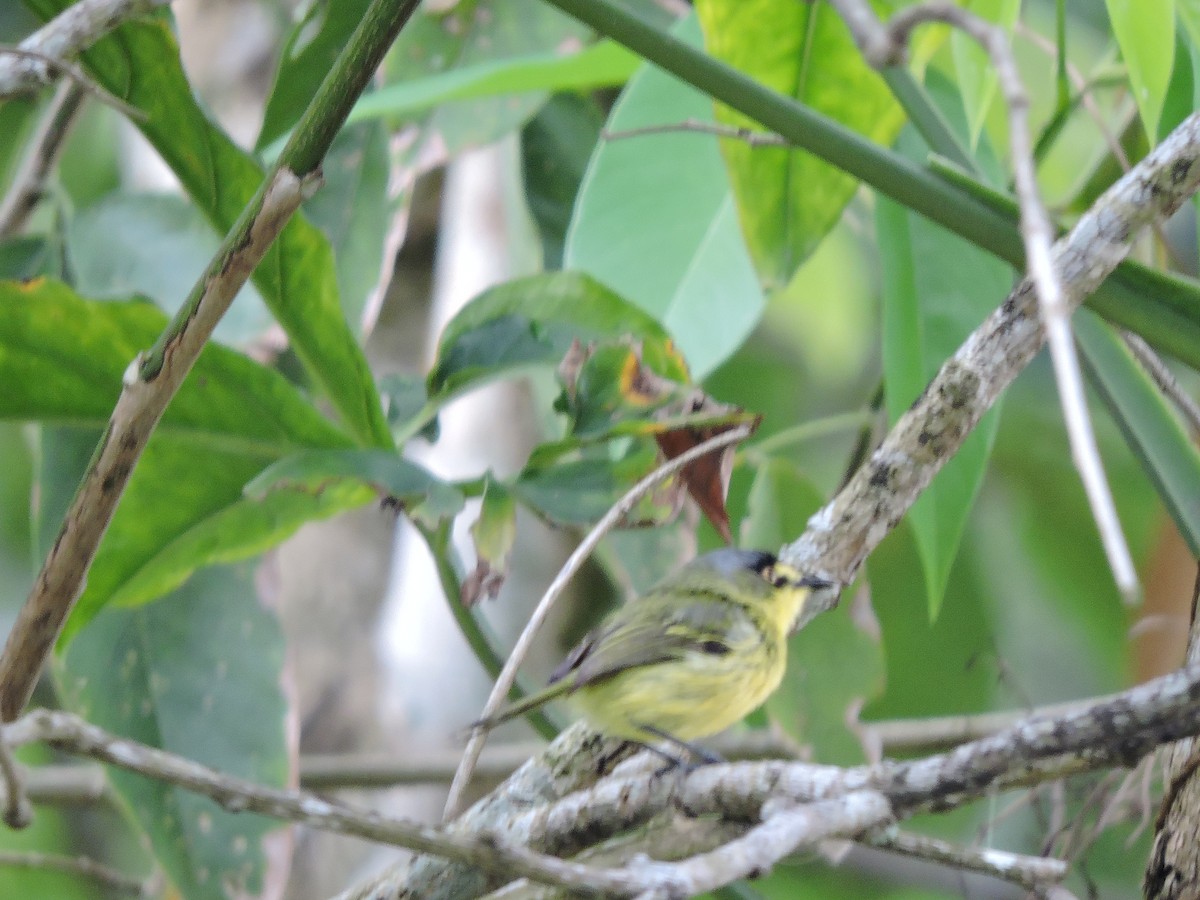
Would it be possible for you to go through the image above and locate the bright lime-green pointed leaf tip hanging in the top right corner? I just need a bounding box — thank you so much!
[1105,0,1175,143]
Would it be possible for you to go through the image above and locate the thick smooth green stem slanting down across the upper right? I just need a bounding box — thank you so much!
[545,0,1200,367]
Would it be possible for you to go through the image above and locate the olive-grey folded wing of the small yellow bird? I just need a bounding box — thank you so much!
[550,598,756,690]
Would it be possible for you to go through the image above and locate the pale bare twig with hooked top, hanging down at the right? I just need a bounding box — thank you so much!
[832,0,1139,602]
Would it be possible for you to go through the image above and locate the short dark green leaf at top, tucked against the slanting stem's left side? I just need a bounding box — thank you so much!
[256,0,371,151]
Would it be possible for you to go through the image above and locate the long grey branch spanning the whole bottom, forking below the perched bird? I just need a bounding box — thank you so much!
[7,664,1200,895]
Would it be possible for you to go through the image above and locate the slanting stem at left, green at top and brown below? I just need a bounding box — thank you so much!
[0,0,427,721]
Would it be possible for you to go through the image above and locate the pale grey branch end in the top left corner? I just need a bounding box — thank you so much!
[0,0,170,98]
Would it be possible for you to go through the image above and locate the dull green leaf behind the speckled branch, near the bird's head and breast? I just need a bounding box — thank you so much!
[740,460,883,764]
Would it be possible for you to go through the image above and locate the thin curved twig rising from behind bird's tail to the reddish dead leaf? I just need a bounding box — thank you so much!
[444,425,754,821]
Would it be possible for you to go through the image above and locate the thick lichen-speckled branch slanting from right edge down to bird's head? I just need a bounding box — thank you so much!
[782,105,1200,600]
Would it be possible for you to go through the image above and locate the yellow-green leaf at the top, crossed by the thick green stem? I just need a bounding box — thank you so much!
[696,0,904,289]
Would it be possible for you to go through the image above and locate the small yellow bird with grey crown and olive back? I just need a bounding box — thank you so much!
[475,548,832,760]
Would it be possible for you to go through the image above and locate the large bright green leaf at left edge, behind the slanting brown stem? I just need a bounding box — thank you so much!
[0,281,367,635]
